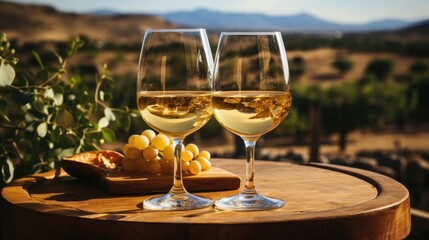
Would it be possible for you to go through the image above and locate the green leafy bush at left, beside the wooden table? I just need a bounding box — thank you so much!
[0,34,135,184]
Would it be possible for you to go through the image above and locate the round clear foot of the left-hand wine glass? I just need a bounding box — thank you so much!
[143,193,213,210]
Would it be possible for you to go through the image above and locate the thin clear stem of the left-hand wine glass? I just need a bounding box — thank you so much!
[170,139,187,195]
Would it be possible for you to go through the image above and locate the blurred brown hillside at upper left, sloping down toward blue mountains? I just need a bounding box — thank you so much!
[0,1,177,43]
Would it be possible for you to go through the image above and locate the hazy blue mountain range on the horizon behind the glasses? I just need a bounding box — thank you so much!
[158,9,412,33]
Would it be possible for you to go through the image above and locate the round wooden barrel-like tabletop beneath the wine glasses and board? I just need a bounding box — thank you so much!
[0,159,411,240]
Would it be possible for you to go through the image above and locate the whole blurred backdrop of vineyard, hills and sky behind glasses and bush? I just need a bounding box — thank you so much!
[0,0,429,239]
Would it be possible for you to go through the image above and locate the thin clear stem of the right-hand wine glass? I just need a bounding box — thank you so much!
[241,139,258,194]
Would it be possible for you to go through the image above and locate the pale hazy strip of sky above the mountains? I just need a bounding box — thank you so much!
[8,0,429,24]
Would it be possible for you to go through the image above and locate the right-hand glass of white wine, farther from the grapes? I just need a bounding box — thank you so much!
[213,32,292,211]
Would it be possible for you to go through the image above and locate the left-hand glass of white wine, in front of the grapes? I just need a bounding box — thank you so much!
[137,29,213,210]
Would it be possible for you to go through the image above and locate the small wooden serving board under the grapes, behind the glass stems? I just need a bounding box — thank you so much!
[101,167,241,194]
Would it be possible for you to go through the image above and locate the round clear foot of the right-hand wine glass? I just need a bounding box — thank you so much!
[215,193,285,211]
